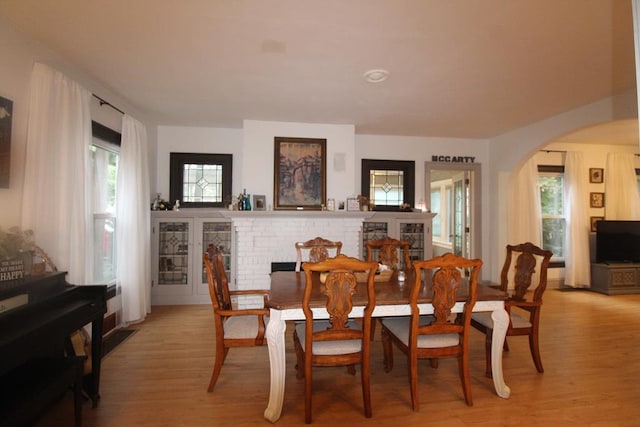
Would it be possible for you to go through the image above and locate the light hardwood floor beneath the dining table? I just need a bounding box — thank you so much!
[39,290,640,427]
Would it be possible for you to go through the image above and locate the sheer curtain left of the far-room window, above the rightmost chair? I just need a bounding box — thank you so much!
[507,157,542,247]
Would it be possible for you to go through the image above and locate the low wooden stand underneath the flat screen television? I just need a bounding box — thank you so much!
[591,262,640,295]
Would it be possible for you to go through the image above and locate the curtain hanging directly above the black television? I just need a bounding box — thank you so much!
[604,153,640,220]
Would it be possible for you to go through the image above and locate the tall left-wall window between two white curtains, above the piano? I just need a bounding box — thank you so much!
[90,122,121,284]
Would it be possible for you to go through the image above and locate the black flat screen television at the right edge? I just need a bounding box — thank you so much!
[596,220,640,263]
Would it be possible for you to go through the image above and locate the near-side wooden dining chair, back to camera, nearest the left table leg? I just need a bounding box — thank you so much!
[294,255,377,424]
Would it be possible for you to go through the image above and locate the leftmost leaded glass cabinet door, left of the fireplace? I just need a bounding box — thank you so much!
[157,222,190,287]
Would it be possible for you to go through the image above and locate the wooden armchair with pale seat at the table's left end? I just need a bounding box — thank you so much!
[202,245,269,392]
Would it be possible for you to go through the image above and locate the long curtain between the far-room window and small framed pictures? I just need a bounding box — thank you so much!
[564,151,591,288]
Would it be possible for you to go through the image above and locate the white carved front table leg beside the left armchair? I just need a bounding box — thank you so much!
[264,309,287,423]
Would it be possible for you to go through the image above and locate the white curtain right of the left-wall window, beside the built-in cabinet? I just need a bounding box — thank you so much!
[116,114,151,324]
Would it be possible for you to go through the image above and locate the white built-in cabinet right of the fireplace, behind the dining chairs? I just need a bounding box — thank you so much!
[362,212,433,268]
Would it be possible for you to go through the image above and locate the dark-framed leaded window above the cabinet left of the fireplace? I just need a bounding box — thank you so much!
[170,153,233,208]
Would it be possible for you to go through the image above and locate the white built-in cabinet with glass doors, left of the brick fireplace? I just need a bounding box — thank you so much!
[151,209,234,305]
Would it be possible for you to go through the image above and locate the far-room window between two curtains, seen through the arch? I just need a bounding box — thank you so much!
[538,165,566,261]
